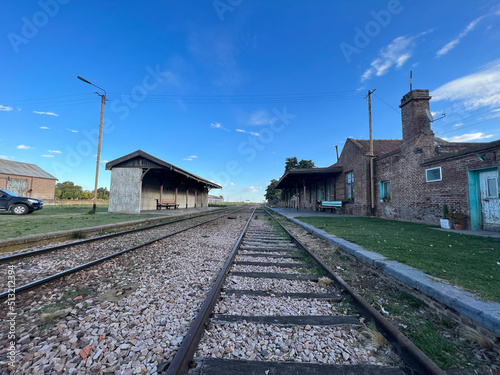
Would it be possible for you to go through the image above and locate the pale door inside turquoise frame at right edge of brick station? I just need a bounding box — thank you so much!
[479,171,500,230]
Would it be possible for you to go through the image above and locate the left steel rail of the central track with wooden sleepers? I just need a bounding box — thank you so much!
[165,208,256,375]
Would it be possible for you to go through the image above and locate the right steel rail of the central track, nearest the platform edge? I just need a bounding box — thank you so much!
[266,209,446,375]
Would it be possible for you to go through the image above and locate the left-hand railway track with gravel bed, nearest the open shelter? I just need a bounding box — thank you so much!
[0,209,242,302]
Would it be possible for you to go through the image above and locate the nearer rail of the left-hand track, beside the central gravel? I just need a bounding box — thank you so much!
[0,209,246,302]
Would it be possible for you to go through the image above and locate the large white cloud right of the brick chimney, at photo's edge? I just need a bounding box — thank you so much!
[431,59,500,110]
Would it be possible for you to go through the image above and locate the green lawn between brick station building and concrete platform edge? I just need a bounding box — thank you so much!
[297,217,500,302]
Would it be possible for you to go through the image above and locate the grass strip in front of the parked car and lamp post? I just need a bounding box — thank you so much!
[0,205,170,239]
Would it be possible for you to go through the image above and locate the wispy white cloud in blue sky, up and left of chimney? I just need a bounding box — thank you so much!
[361,34,414,82]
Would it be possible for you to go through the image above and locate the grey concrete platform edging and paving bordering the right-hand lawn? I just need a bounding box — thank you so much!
[272,208,500,335]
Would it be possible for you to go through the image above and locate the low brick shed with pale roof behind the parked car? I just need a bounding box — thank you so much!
[0,159,57,199]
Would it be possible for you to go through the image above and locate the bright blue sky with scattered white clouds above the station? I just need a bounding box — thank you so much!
[0,0,500,201]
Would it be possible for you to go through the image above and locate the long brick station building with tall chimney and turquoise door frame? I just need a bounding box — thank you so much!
[277,90,500,231]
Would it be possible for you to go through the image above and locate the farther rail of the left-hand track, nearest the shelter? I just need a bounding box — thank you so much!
[0,208,241,264]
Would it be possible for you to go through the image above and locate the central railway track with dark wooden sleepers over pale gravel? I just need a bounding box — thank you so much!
[164,210,444,375]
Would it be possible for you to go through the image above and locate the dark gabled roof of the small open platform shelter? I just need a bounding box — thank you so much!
[106,150,222,189]
